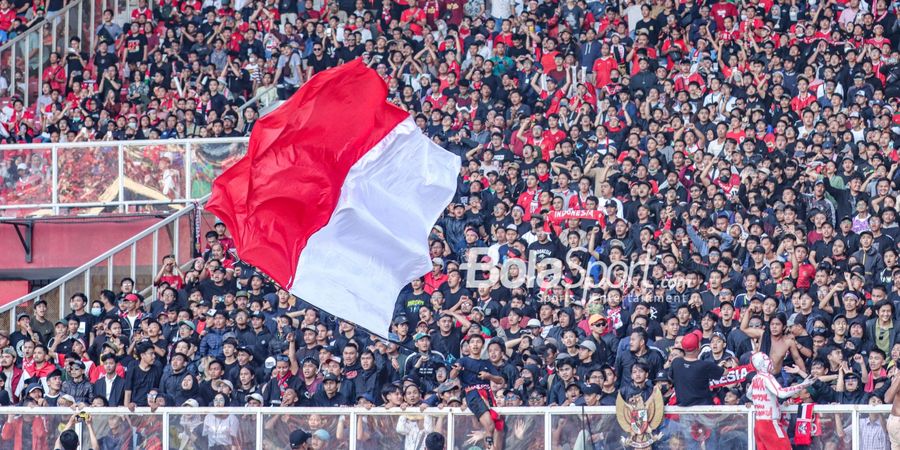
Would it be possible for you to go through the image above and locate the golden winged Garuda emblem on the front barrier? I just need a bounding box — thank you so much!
[616,388,663,449]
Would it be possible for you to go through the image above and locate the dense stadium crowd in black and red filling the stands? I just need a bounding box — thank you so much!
[0,0,900,448]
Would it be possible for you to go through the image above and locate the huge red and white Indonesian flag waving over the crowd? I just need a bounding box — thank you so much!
[207,60,460,335]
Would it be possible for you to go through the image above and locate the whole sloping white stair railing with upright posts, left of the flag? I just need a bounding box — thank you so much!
[0,195,208,332]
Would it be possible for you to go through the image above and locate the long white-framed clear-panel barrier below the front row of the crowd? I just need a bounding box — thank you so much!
[0,405,890,450]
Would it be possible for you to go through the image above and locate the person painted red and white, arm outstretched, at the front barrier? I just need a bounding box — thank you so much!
[747,352,816,450]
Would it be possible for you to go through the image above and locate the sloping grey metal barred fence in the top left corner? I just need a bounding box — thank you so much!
[0,0,131,108]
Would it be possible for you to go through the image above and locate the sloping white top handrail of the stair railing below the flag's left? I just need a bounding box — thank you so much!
[0,195,209,331]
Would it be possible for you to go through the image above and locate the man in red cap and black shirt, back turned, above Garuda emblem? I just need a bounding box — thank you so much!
[670,330,725,406]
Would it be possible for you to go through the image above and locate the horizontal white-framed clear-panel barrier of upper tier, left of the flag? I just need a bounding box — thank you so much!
[0,137,248,218]
